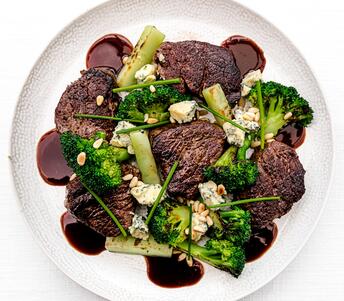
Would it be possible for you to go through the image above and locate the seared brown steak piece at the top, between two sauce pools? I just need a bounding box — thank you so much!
[155,41,241,103]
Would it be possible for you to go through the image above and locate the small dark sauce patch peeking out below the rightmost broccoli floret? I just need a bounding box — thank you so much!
[276,123,306,148]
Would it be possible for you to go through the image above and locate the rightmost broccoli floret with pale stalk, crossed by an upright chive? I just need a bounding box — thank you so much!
[247,81,313,135]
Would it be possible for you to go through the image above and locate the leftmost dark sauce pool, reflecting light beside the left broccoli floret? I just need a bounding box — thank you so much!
[37,129,73,186]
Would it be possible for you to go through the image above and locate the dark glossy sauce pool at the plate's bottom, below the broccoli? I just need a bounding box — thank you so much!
[146,255,204,288]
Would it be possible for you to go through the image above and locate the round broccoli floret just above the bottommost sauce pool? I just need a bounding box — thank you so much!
[149,200,190,246]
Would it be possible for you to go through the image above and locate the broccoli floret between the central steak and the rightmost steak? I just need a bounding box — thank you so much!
[203,146,258,193]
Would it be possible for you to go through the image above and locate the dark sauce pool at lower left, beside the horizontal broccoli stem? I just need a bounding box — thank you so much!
[61,212,105,255]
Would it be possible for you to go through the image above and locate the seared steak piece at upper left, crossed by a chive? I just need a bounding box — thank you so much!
[55,68,118,138]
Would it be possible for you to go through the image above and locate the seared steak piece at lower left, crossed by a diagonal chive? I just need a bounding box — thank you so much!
[65,164,140,236]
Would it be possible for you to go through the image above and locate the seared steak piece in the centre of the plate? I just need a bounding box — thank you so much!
[151,121,225,199]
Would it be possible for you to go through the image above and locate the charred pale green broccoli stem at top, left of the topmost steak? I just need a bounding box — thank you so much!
[117,25,165,87]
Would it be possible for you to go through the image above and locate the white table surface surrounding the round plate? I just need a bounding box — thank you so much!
[0,0,344,301]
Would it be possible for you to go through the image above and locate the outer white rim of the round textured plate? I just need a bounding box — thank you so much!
[8,0,336,300]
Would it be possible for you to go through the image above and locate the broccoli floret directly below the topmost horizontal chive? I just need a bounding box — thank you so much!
[116,85,191,121]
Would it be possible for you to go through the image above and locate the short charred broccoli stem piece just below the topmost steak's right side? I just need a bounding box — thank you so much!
[202,84,231,126]
